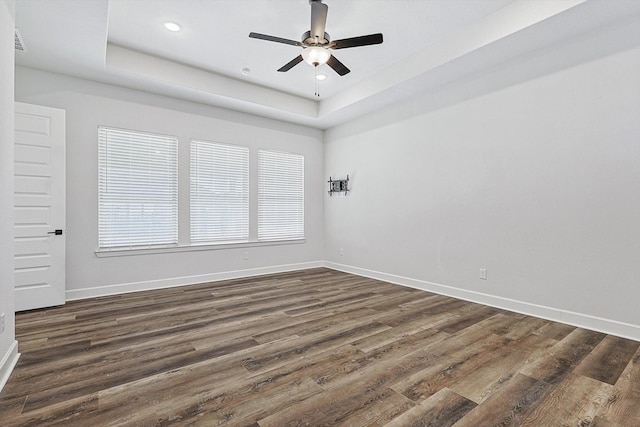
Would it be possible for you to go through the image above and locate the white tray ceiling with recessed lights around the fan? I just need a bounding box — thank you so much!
[16,0,640,129]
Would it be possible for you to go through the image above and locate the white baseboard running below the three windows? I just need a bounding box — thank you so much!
[65,261,324,301]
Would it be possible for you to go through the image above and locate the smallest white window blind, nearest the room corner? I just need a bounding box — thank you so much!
[258,150,304,240]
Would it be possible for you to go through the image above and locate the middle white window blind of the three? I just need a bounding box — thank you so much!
[191,140,249,243]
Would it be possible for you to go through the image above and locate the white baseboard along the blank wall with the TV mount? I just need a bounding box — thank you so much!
[324,262,640,341]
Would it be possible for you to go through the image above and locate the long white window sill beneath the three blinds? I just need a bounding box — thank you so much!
[95,238,306,258]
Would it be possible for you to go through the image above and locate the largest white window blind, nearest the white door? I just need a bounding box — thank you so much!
[98,127,178,248]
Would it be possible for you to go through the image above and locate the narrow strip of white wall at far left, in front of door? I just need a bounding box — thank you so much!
[0,0,17,390]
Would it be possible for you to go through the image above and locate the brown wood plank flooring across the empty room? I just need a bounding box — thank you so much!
[0,269,640,427]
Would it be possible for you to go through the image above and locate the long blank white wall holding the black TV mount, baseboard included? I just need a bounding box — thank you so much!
[325,48,640,339]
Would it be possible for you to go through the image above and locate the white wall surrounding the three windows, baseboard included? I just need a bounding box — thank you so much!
[15,67,323,299]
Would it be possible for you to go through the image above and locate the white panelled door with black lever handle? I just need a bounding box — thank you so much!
[15,102,66,311]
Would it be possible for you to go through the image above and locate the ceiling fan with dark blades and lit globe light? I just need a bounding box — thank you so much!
[249,0,382,76]
